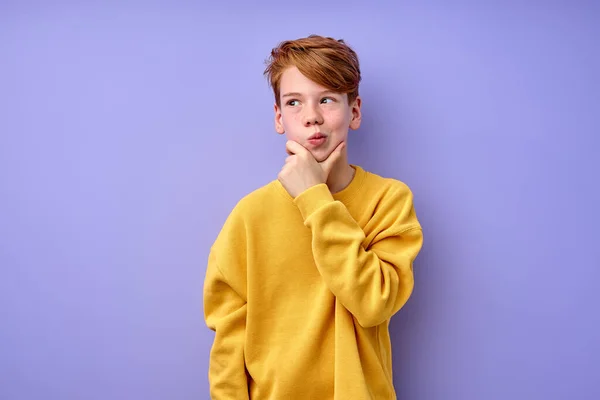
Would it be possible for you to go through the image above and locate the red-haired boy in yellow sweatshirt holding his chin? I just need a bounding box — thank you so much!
[204,35,423,400]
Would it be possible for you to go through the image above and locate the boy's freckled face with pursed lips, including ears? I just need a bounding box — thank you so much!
[275,67,361,162]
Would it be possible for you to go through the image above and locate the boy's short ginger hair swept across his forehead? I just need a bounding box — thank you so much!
[264,35,361,106]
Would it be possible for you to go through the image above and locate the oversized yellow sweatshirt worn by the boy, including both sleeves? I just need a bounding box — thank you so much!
[204,165,423,400]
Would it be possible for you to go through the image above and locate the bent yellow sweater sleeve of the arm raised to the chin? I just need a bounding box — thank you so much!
[294,184,423,327]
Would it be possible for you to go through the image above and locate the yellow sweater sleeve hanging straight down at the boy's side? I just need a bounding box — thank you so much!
[204,250,249,400]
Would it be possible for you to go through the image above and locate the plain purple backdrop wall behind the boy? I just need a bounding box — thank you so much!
[0,0,600,400]
